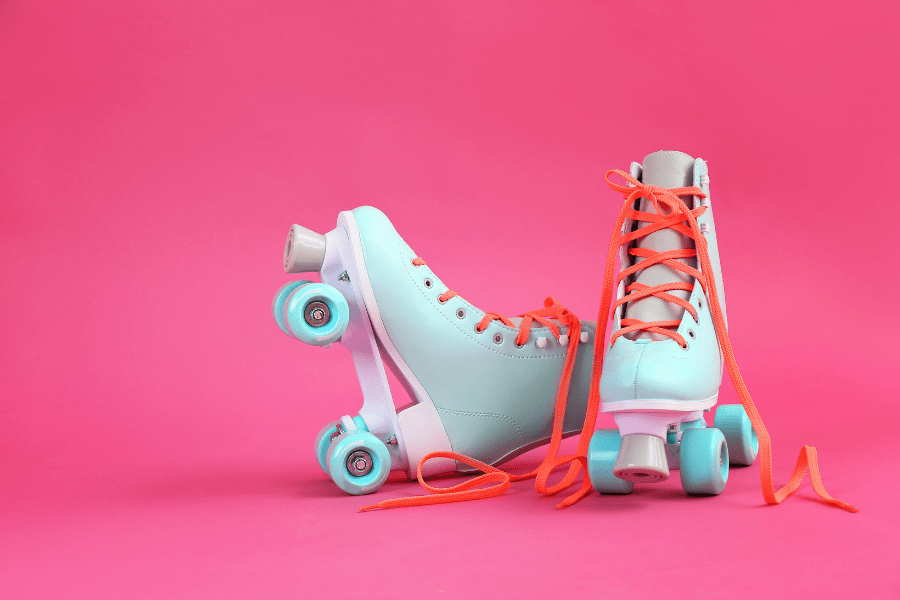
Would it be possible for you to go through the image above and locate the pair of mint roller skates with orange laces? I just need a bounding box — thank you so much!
[272,151,852,509]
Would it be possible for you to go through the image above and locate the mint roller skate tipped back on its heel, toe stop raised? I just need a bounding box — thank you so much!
[272,207,595,495]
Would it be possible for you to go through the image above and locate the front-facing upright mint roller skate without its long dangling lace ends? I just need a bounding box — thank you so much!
[588,152,744,494]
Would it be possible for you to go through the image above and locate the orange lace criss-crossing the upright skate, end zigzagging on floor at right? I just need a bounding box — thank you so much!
[592,170,857,512]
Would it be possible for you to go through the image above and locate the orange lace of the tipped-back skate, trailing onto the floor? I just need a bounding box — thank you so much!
[360,257,599,511]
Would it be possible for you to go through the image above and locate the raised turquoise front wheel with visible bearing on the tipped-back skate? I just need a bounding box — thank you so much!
[282,283,350,346]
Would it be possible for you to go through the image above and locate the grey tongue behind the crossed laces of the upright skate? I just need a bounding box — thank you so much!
[625,150,697,341]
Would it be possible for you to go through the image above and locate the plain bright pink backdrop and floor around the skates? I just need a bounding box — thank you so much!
[0,0,900,598]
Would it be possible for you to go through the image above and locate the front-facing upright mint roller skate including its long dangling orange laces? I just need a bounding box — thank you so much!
[587,151,856,512]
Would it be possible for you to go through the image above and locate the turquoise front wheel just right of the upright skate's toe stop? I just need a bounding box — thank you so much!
[678,427,728,496]
